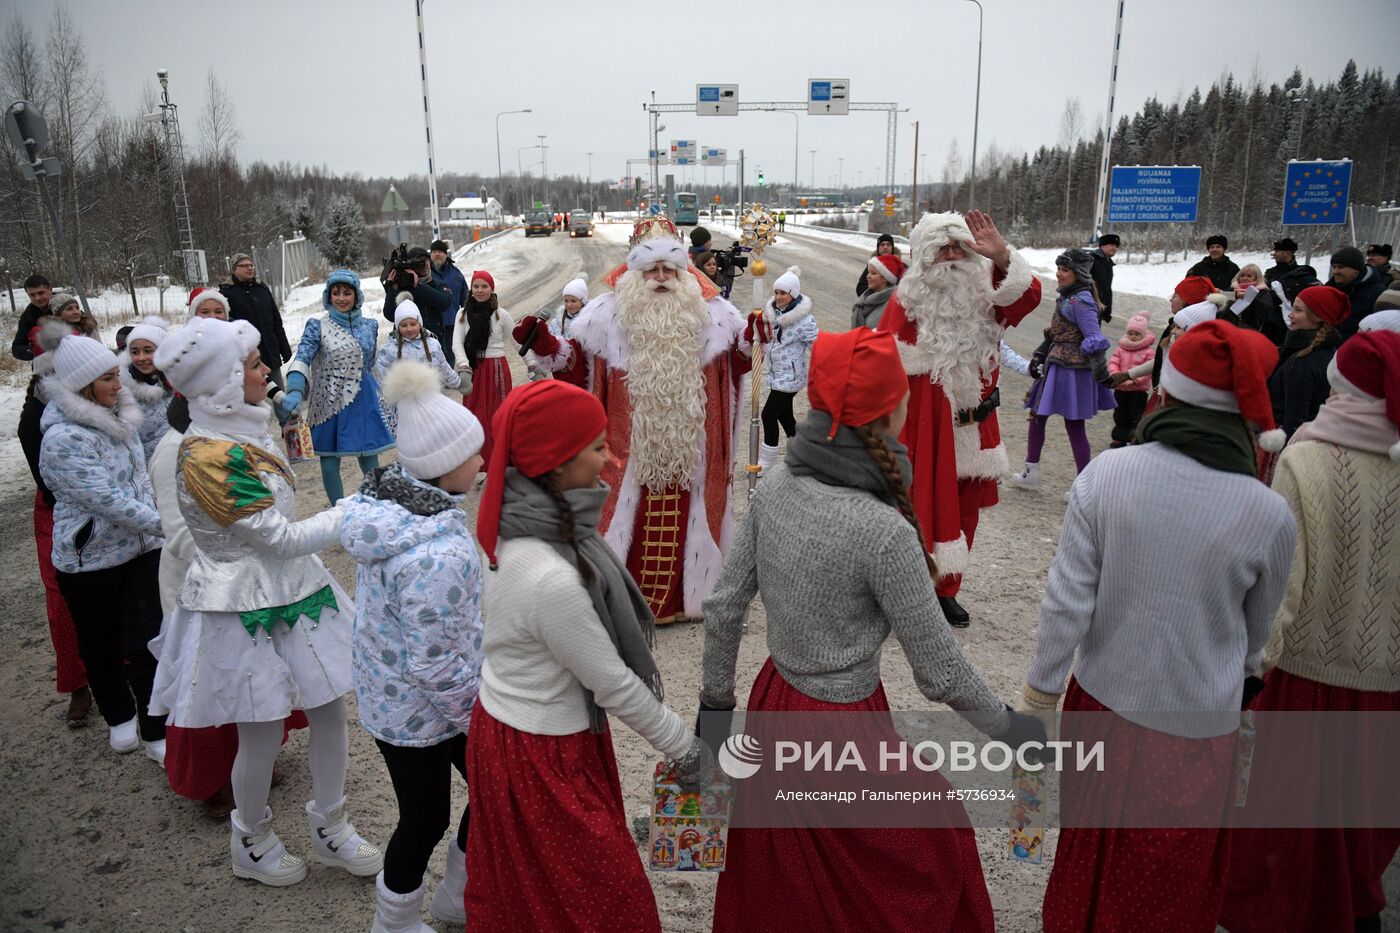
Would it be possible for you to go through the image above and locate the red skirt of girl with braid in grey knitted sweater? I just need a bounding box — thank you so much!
[711,658,994,933]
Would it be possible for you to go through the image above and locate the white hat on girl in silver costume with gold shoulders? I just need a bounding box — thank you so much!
[155,318,262,412]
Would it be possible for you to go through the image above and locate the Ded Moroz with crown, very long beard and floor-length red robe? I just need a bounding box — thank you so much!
[532,217,752,625]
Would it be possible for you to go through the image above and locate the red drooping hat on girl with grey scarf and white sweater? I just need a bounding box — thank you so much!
[476,380,608,570]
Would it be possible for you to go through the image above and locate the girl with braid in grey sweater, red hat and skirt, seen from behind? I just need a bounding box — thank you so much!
[700,328,1044,933]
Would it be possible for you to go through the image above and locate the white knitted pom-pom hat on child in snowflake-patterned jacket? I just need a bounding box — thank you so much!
[382,360,486,481]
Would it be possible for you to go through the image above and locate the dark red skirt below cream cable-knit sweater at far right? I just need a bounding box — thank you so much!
[1221,668,1400,933]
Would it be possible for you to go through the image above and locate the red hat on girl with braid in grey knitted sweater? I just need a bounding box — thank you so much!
[806,328,909,440]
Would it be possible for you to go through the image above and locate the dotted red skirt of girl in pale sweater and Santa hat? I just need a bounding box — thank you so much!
[1043,678,1235,933]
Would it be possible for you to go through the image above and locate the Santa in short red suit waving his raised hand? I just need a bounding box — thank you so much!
[878,210,1040,628]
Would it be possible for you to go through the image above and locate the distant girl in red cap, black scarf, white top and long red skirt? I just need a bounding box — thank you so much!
[452,269,515,469]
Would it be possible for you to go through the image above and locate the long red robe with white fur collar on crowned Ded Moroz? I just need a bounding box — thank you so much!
[570,268,753,623]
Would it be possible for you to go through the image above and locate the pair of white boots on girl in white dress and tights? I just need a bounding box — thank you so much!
[228,797,383,885]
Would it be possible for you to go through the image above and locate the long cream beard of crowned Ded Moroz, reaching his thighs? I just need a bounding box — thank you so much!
[615,269,710,489]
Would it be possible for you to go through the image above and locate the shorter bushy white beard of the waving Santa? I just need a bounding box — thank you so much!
[897,258,1004,409]
